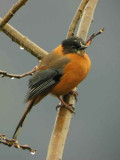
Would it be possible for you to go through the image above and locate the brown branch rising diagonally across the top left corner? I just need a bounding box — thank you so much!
[0,0,28,30]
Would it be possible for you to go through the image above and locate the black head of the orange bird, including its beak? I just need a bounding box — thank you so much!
[62,37,87,54]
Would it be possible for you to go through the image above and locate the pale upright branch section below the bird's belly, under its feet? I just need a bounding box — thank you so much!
[46,95,75,160]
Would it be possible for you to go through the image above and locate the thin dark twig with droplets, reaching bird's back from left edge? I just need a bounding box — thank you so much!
[0,70,34,79]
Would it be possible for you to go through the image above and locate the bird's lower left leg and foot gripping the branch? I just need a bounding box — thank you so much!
[56,97,74,113]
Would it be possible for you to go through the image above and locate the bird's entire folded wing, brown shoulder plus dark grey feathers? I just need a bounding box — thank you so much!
[25,56,70,102]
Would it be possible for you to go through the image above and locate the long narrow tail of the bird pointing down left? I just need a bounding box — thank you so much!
[12,98,36,139]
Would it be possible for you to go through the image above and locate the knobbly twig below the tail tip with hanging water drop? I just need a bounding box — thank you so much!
[0,134,36,154]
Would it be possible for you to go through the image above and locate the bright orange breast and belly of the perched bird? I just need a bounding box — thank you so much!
[51,53,91,96]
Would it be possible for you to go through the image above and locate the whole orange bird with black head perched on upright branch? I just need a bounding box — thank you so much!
[13,36,91,139]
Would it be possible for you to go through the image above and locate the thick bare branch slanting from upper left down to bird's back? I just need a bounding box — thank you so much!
[0,18,48,59]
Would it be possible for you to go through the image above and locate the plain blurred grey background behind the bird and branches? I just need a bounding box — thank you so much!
[0,0,120,160]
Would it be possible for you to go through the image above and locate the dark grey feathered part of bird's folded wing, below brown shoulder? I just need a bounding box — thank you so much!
[25,68,62,102]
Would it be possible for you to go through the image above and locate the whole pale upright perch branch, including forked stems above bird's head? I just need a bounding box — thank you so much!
[46,0,98,160]
